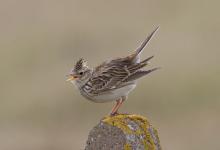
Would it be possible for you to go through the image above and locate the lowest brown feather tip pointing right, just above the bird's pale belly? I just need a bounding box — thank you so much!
[124,68,159,82]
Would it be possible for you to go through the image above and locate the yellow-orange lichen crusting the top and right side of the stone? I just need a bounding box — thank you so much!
[102,114,159,150]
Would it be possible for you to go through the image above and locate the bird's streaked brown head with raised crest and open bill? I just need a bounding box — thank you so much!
[67,58,91,82]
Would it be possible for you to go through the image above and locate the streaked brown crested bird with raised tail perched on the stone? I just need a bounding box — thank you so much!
[67,26,159,115]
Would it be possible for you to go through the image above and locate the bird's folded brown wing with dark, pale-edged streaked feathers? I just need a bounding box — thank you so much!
[85,56,153,94]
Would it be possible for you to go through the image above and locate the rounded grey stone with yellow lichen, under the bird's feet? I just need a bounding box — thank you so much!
[85,114,161,150]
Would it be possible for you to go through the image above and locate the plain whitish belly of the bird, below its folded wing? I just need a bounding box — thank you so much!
[87,84,136,103]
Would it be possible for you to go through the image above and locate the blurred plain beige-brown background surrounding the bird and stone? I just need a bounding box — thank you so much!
[0,0,220,150]
